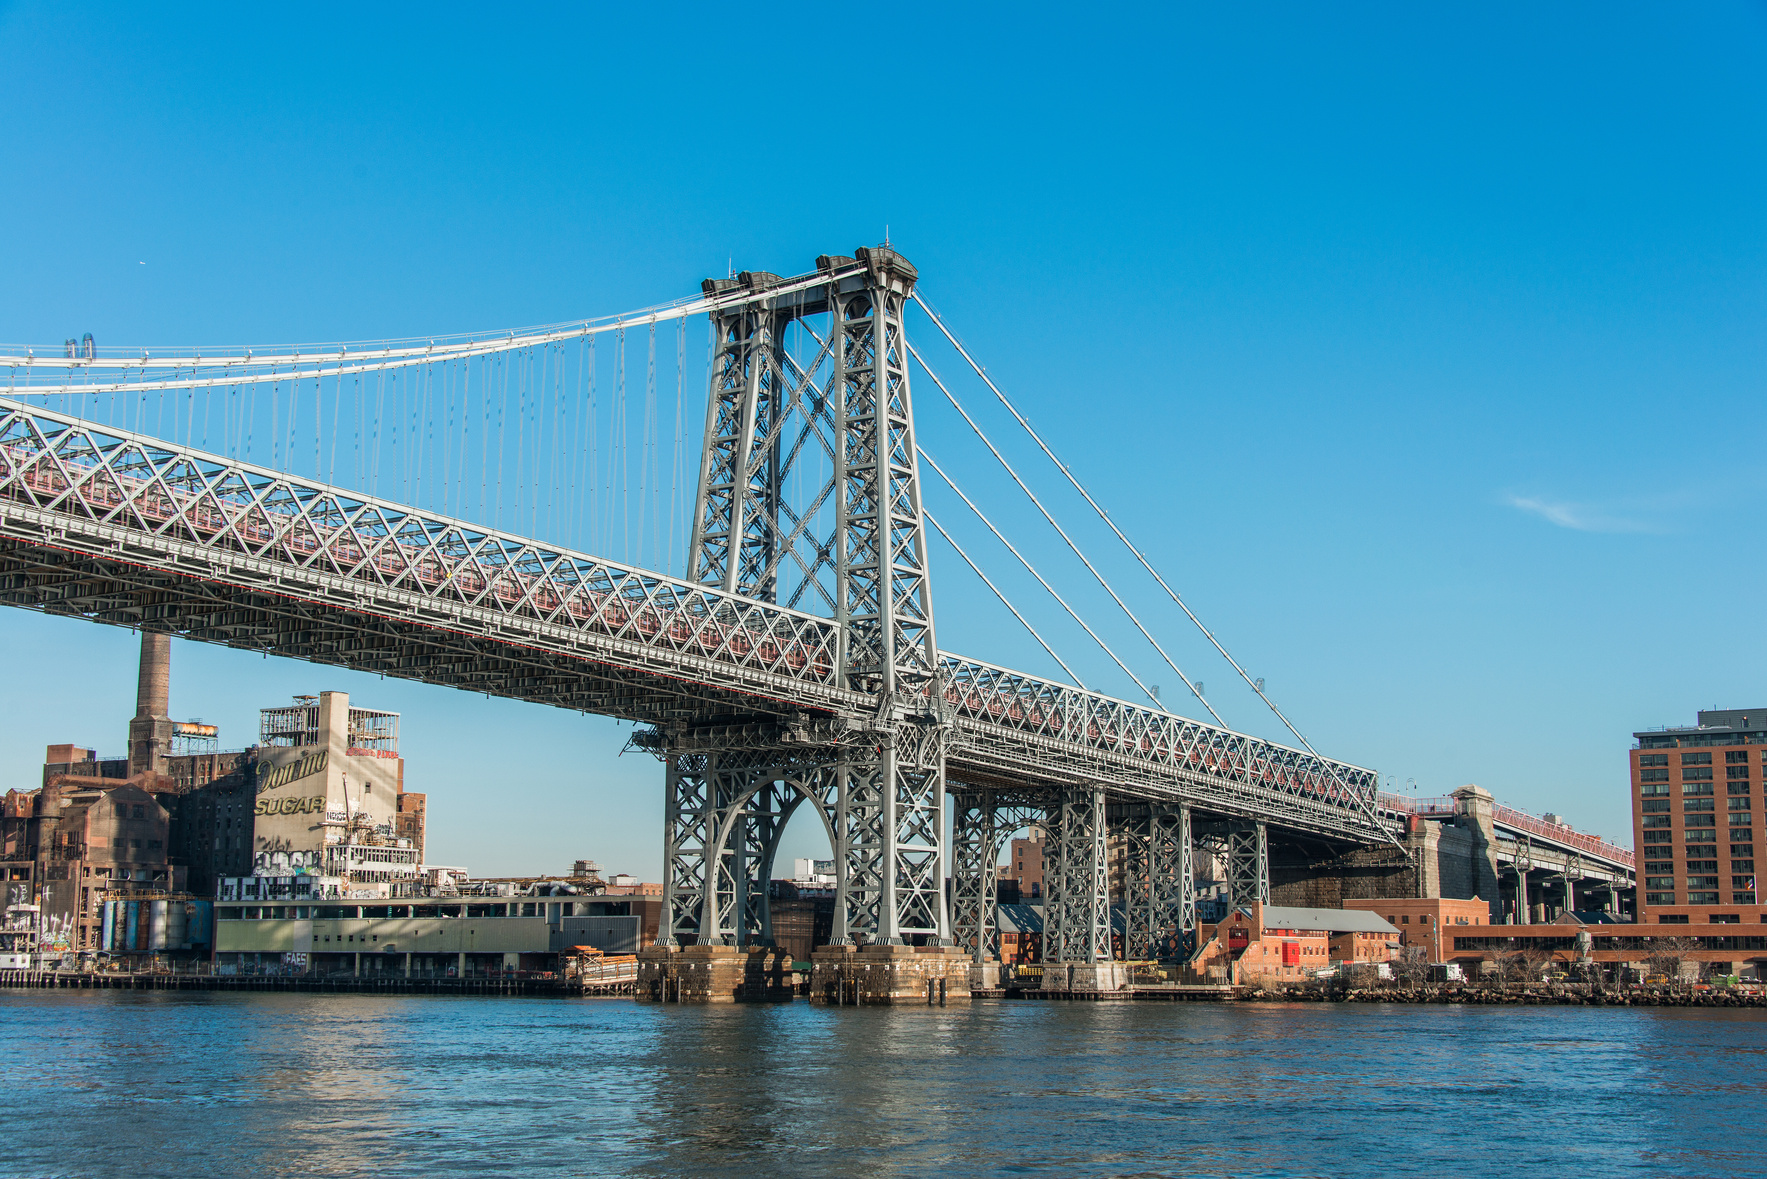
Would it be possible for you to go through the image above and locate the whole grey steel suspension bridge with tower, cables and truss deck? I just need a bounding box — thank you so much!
[0,247,1620,996]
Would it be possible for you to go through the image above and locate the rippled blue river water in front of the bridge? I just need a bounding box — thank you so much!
[0,992,1767,1179]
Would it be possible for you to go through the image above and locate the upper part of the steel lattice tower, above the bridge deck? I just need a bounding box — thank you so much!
[689,247,938,695]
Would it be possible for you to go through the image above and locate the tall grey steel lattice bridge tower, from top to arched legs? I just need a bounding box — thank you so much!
[656,247,951,946]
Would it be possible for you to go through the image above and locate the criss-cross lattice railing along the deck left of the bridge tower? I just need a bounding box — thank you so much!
[0,398,838,686]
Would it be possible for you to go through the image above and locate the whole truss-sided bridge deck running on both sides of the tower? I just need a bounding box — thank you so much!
[0,398,1392,843]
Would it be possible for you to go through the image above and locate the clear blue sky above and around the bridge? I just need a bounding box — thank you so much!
[0,4,1767,879]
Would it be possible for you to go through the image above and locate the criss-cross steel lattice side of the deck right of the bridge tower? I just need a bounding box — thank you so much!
[942,654,1378,825]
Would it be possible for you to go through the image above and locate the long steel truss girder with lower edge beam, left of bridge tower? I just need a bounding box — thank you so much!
[0,398,845,700]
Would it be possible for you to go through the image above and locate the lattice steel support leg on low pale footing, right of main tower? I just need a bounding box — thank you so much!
[1043,787,1111,962]
